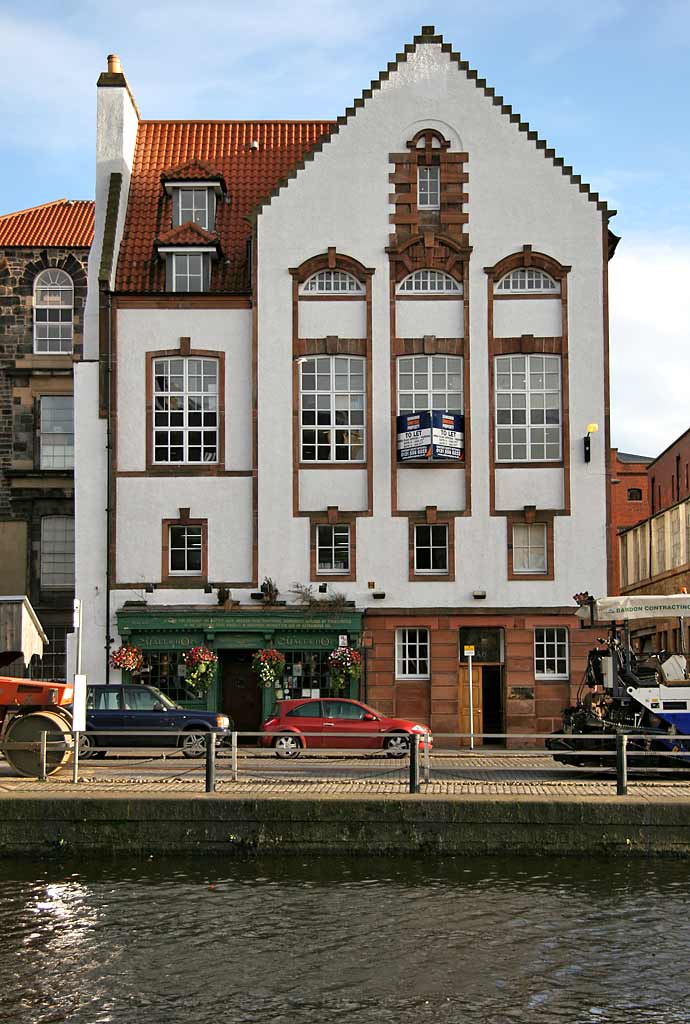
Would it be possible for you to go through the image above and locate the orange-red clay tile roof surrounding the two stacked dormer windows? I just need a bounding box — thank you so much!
[116,121,332,292]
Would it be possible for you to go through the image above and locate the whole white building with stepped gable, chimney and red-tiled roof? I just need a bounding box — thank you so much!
[72,28,612,732]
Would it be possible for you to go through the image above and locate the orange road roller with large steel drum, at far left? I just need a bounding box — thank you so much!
[0,676,74,777]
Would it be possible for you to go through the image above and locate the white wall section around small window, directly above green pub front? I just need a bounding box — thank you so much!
[117,476,252,581]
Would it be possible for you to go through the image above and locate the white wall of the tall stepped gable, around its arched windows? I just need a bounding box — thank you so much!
[258,44,606,608]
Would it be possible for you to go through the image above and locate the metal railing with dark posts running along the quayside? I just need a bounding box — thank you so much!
[4,729,690,797]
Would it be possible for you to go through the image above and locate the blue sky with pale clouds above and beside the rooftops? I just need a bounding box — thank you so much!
[0,0,690,456]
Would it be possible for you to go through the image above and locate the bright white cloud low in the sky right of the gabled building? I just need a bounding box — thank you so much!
[609,234,690,455]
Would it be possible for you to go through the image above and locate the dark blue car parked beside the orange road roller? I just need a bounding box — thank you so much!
[79,684,230,758]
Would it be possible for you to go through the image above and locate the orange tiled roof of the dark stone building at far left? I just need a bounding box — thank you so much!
[0,199,95,249]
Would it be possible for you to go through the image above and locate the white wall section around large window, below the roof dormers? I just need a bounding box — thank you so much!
[117,309,252,471]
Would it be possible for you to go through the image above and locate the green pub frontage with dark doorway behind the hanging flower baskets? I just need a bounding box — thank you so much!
[118,601,362,731]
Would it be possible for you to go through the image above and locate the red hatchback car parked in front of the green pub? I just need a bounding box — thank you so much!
[261,697,432,758]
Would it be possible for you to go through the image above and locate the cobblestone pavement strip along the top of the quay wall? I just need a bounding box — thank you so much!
[0,754,690,802]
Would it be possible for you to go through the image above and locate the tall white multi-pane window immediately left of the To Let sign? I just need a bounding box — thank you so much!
[299,355,366,465]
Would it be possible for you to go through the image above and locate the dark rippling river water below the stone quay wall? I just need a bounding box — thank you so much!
[0,855,690,1024]
